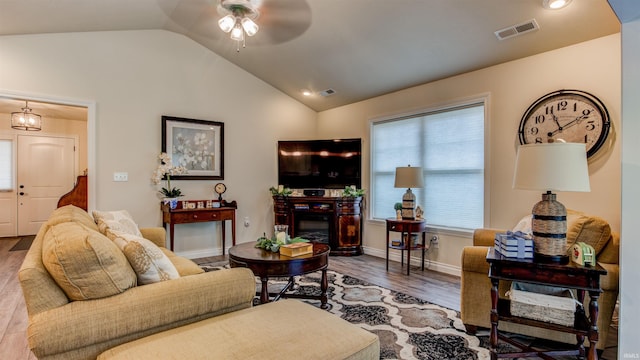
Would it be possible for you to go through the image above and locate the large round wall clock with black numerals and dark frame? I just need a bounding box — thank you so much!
[518,90,611,157]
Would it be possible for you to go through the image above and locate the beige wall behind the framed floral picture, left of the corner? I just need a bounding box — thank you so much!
[0,30,316,257]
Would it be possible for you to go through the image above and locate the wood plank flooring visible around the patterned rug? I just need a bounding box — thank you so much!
[0,238,617,360]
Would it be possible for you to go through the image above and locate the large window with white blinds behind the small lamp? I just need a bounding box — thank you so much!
[371,103,484,229]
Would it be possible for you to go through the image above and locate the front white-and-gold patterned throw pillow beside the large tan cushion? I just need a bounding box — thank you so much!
[107,229,180,285]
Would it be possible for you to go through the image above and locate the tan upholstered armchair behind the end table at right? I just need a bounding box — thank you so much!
[460,210,620,350]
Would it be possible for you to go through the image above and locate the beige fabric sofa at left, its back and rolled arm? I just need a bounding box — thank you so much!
[19,205,255,360]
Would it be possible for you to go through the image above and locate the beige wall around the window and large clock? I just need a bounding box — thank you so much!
[318,34,621,273]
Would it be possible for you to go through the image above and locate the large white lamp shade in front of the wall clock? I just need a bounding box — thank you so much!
[513,142,591,192]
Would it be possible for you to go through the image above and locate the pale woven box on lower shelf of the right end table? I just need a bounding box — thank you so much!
[507,281,579,326]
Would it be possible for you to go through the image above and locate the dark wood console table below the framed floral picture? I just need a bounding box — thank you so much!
[160,200,238,255]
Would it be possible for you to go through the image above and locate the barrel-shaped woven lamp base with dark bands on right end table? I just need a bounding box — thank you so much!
[531,193,567,257]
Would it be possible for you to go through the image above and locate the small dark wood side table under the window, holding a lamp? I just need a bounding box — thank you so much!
[386,219,427,275]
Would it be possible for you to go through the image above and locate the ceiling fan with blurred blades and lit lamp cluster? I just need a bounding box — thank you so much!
[158,0,311,46]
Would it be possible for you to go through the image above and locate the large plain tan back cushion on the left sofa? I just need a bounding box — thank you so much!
[42,222,136,300]
